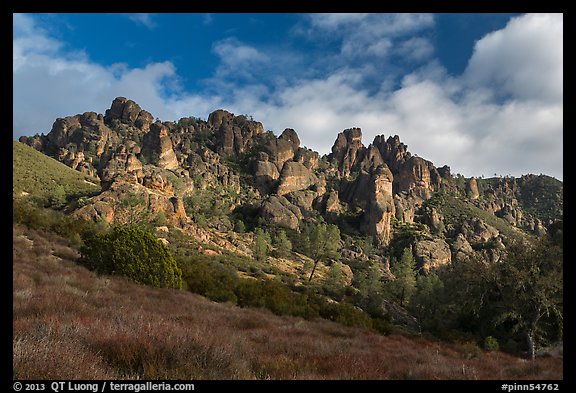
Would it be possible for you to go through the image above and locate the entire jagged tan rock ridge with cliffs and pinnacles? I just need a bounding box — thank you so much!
[21,97,562,270]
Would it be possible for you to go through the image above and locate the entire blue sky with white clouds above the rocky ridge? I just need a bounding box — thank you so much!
[13,13,563,179]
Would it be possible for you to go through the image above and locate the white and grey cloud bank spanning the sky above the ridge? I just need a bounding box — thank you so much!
[13,14,563,179]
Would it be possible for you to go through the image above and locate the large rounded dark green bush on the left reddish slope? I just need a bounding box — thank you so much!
[80,226,182,289]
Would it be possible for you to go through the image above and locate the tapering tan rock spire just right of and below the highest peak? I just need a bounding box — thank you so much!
[140,122,179,169]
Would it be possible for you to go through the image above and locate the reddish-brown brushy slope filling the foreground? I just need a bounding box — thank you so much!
[13,226,563,380]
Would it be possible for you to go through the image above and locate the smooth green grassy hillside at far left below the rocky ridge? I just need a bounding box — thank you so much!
[12,141,100,204]
